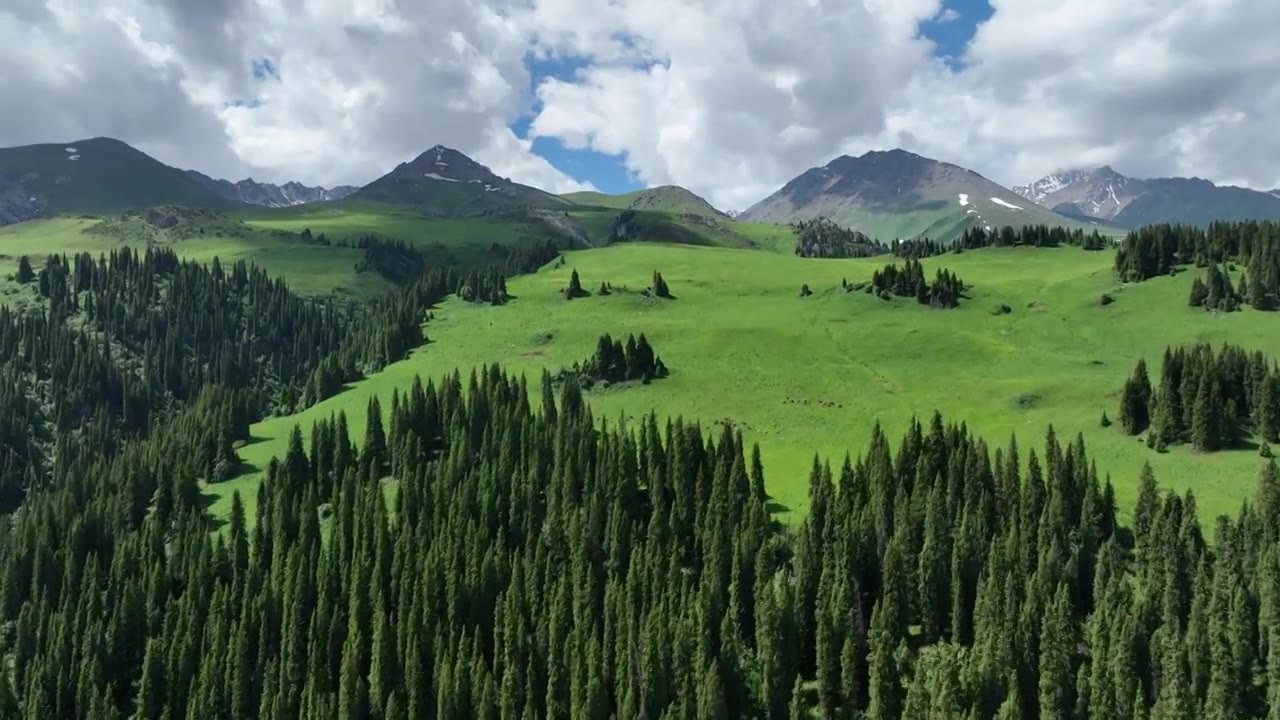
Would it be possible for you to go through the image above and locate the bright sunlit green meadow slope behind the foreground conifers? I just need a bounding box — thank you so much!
[211,243,1280,519]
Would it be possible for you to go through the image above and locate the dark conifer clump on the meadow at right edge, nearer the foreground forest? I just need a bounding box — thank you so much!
[1120,343,1280,452]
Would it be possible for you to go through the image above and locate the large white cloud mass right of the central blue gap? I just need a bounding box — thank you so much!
[532,0,1280,208]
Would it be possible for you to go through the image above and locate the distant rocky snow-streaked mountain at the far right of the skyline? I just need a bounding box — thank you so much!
[1014,165,1280,228]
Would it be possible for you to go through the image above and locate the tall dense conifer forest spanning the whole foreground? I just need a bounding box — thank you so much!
[12,356,1280,720]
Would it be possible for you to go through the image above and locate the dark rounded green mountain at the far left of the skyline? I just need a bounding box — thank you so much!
[0,137,239,224]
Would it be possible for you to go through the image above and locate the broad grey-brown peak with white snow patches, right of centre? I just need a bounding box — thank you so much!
[739,150,1106,242]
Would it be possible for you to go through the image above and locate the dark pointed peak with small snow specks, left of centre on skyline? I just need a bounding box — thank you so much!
[348,145,573,217]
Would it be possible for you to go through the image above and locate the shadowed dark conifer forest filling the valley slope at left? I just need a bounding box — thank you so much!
[0,238,558,510]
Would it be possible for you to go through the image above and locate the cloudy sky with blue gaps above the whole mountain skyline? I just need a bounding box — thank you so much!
[0,0,1280,209]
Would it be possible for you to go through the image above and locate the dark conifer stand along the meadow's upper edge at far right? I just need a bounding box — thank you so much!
[1115,220,1280,310]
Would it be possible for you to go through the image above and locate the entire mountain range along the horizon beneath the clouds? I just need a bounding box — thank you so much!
[0,137,1280,241]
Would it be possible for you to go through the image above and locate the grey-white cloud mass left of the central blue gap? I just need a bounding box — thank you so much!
[0,0,582,190]
